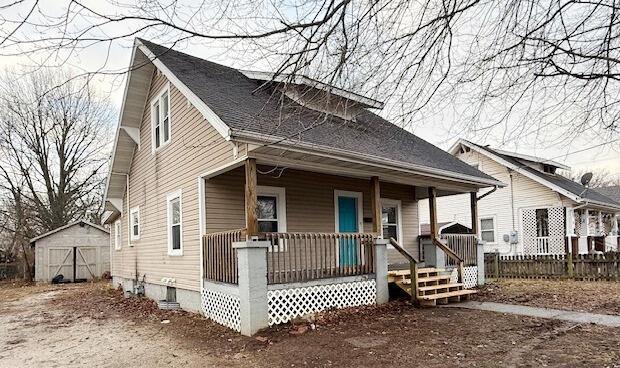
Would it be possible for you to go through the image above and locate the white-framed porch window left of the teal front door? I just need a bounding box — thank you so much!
[257,186,286,233]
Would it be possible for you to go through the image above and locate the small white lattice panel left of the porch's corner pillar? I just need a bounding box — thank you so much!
[202,285,241,332]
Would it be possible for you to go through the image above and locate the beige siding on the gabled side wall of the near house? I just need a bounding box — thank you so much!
[112,71,237,290]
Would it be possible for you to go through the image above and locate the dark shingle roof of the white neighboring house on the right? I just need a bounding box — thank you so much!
[469,142,620,206]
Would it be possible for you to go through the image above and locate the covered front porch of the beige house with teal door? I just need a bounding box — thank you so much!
[202,159,478,334]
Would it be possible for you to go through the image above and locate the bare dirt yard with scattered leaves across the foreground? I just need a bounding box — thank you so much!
[0,283,620,368]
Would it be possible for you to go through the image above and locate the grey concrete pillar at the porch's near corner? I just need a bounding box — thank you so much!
[233,240,270,336]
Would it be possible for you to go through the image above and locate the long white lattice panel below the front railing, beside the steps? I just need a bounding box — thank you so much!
[267,279,377,326]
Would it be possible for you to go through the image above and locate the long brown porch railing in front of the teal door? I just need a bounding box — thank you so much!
[259,233,375,284]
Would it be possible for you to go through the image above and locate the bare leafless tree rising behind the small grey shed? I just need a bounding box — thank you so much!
[0,71,113,231]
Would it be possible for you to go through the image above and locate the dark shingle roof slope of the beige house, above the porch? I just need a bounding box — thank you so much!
[140,40,496,181]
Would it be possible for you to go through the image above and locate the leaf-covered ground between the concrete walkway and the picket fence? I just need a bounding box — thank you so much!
[474,280,620,315]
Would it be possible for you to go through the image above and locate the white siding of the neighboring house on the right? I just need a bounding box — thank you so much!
[419,151,574,254]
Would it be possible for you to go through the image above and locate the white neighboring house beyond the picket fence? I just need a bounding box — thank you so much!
[420,139,620,255]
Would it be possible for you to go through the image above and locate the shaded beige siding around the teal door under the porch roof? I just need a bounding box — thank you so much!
[205,167,419,263]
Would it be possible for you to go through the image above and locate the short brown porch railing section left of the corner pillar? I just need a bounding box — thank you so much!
[202,229,245,284]
